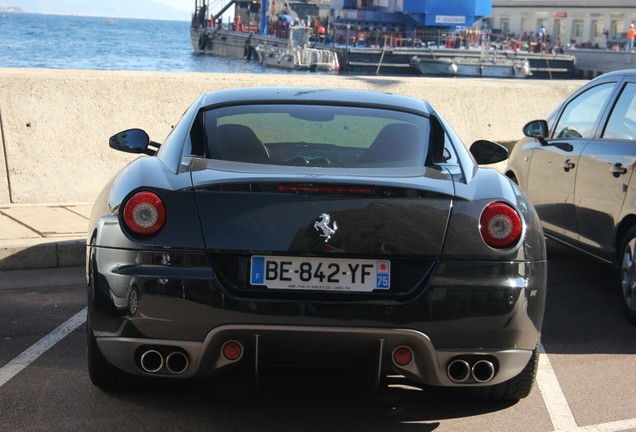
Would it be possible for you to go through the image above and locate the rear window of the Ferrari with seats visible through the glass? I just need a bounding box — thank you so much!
[203,104,429,168]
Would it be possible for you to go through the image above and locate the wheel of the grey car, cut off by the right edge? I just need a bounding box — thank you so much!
[618,227,636,324]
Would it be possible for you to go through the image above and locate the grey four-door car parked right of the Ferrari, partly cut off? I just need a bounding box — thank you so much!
[506,70,636,322]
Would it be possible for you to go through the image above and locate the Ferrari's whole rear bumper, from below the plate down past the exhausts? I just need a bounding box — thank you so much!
[89,248,547,386]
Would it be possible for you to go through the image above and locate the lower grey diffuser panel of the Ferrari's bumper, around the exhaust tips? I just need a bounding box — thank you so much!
[97,324,532,386]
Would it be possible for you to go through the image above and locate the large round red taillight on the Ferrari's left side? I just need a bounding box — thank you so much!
[124,191,166,235]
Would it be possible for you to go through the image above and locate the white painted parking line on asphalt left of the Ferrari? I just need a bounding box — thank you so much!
[0,308,86,387]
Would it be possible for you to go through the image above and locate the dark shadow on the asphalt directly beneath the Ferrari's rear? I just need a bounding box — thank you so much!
[96,369,515,432]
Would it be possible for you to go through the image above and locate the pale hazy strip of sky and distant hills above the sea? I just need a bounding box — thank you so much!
[0,0,191,21]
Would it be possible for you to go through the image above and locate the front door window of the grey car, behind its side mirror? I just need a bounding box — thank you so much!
[553,82,616,138]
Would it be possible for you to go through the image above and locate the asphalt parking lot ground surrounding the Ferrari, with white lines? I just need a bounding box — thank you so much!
[0,242,636,432]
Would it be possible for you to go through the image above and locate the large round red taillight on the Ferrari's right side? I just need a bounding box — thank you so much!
[479,202,523,249]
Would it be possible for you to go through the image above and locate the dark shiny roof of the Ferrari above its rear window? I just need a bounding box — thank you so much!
[204,87,431,114]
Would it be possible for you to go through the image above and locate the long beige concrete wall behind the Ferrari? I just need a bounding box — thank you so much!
[0,69,583,204]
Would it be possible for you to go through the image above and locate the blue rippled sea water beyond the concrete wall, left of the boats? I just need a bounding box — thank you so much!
[0,12,287,73]
